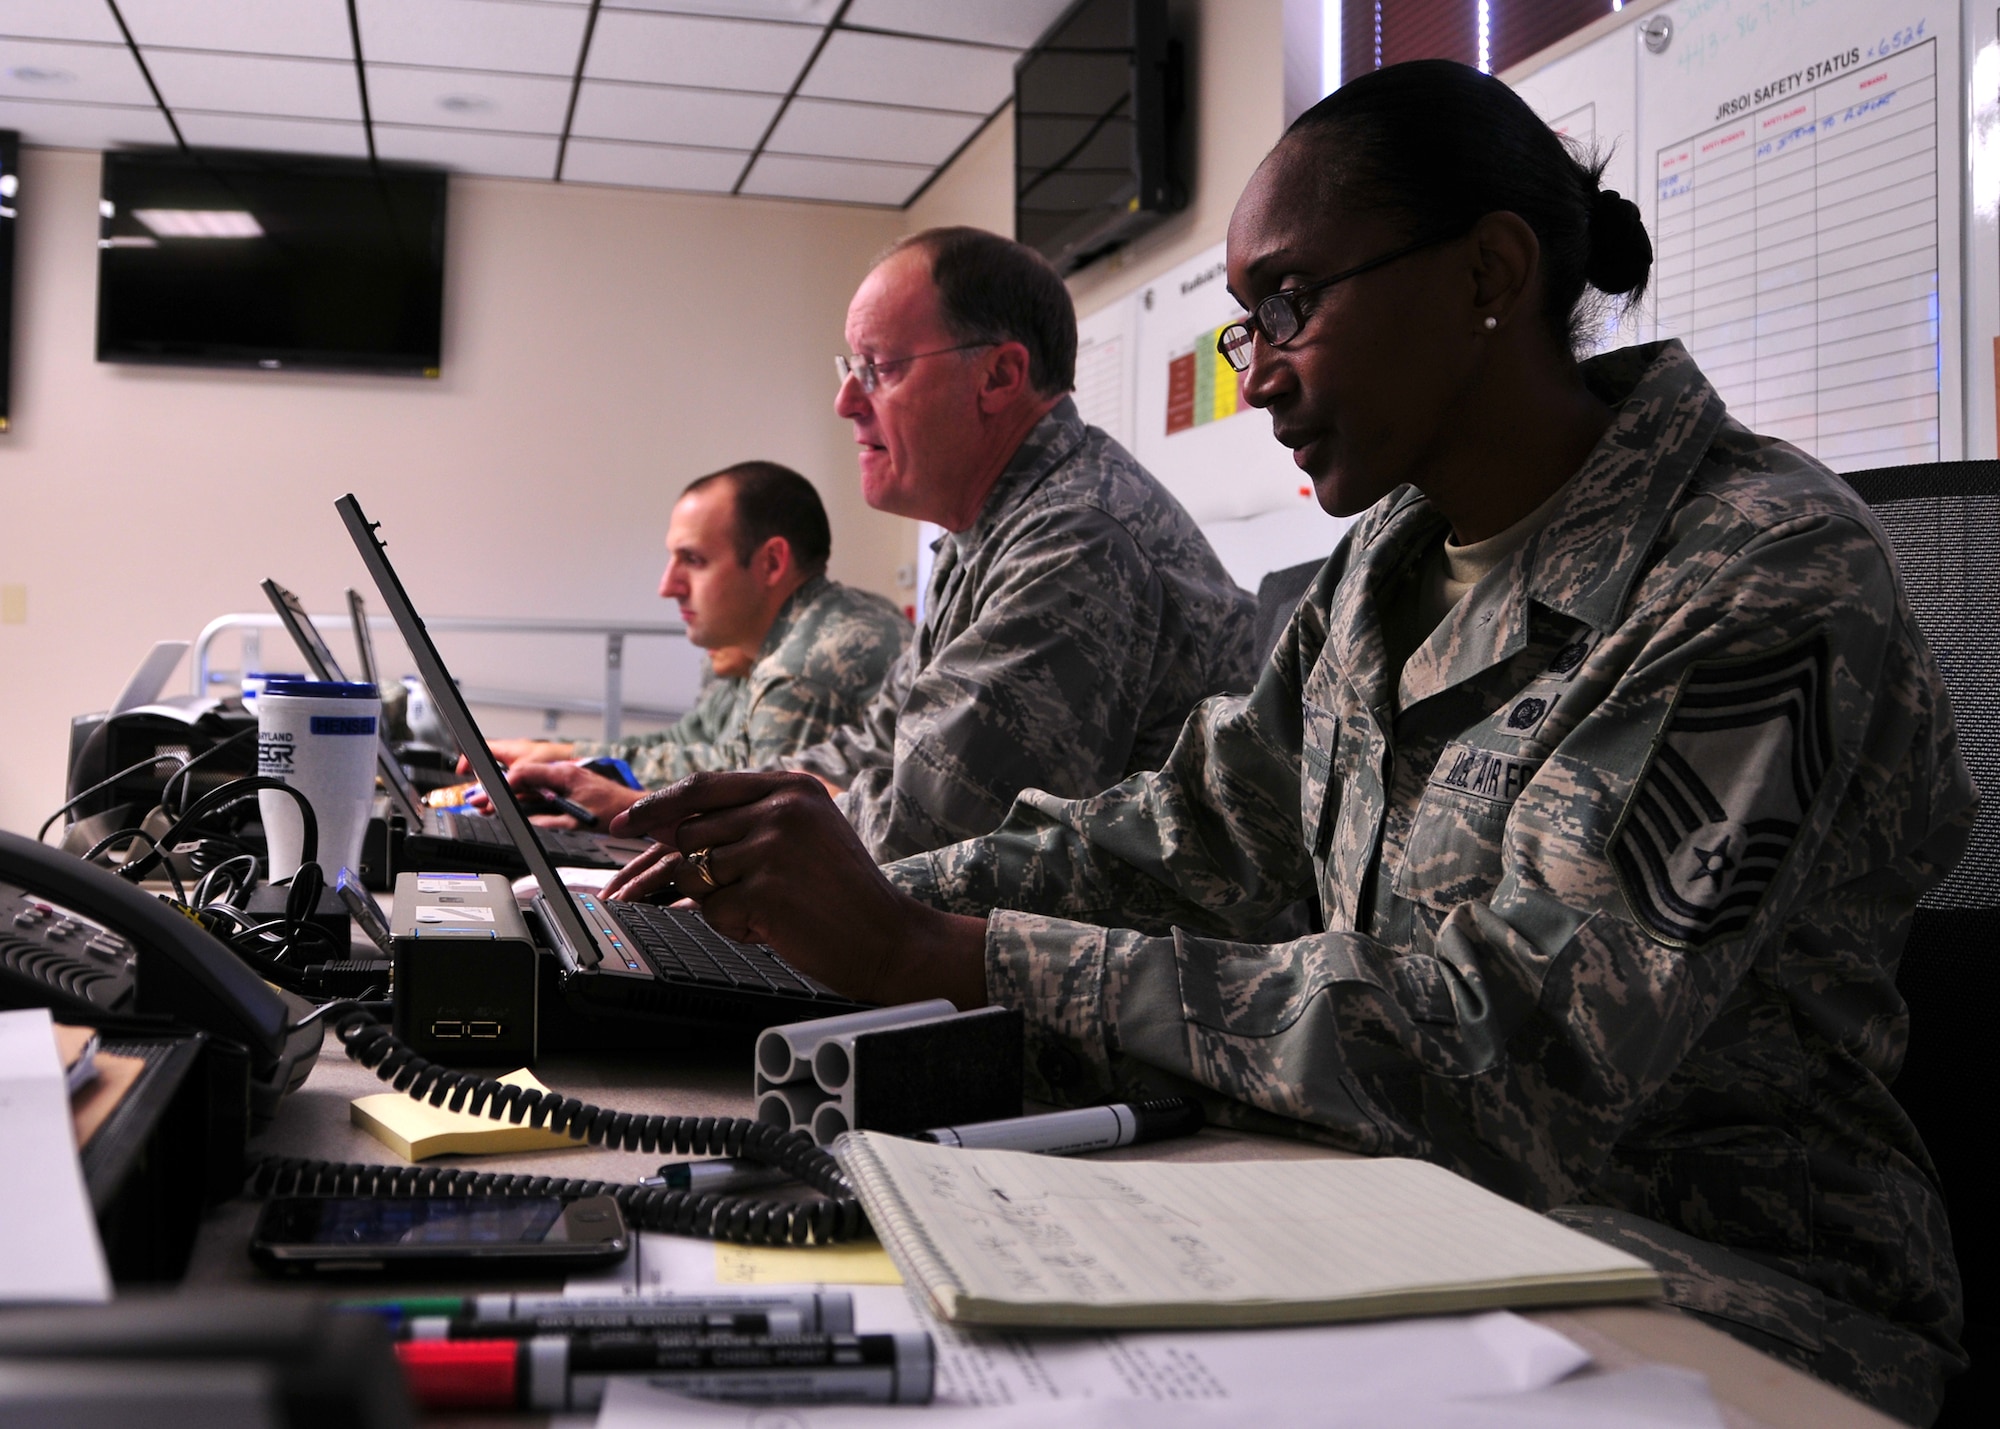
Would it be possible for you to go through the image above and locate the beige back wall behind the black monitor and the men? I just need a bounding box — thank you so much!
[0,150,912,831]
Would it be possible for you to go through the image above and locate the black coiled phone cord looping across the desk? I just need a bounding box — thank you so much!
[248,1009,868,1245]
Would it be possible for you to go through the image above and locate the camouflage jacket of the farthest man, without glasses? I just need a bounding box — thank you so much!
[576,576,910,789]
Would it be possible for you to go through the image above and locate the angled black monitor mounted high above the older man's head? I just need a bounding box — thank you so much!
[1014,0,1188,272]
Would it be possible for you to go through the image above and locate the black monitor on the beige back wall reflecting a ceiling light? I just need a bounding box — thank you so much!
[98,150,446,376]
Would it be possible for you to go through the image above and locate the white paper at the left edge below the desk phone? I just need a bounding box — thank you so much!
[0,1007,112,1305]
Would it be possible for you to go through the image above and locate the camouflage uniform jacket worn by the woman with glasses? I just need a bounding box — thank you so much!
[892,342,1976,1353]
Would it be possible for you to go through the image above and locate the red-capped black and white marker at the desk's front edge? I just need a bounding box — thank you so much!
[396,1331,936,1409]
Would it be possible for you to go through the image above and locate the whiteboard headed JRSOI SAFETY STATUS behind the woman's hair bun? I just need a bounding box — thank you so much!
[1510,0,1960,470]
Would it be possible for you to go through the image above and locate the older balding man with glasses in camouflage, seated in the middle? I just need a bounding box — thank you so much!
[786,228,1254,861]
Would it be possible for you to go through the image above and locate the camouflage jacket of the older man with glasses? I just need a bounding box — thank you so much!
[786,398,1256,861]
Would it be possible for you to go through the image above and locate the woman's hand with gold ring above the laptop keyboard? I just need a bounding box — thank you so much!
[604,773,986,1007]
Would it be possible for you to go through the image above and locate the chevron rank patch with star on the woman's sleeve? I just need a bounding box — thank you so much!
[1612,636,1832,947]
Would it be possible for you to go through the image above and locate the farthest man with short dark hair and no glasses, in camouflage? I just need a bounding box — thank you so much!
[492,462,910,800]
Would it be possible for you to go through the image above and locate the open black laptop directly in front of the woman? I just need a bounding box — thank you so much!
[334,496,860,1029]
